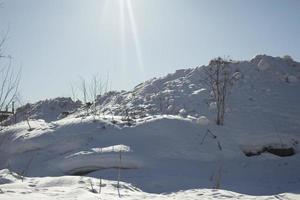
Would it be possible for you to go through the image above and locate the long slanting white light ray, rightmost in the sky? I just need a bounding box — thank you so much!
[125,0,144,75]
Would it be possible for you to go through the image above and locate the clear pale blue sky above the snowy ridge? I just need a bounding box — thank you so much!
[0,0,300,101]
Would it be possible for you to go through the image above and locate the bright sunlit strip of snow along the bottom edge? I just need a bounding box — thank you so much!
[0,169,300,200]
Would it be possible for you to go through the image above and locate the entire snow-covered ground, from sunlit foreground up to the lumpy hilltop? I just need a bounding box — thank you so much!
[0,55,300,199]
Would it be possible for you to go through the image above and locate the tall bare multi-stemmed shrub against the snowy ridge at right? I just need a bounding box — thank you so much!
[203,57,235,125]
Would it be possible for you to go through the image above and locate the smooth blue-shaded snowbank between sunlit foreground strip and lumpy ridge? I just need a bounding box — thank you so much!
[0,116,300,195]
